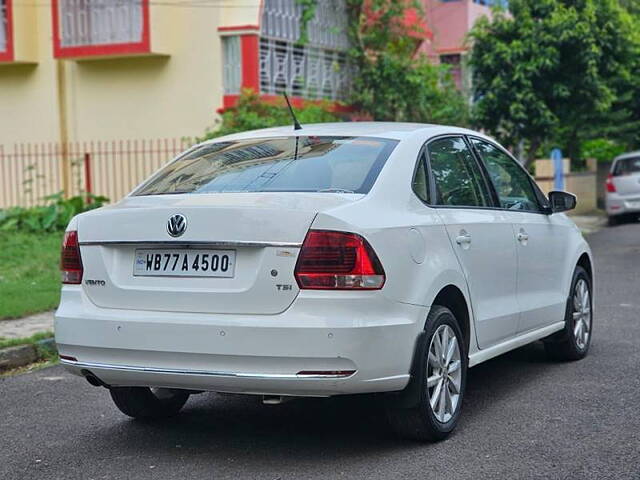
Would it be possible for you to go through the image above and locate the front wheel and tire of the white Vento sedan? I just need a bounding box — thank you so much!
[544,266,593,361]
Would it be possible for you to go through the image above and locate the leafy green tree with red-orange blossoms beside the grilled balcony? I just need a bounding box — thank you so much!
[348,0,468,125]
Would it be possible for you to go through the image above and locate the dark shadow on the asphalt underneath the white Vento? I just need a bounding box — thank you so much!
[89,345,558,461]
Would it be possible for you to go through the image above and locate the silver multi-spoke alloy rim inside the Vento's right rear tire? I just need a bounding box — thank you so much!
[427,325,462,423]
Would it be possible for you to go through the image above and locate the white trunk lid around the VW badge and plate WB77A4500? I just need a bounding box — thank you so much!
[78,193,363,314]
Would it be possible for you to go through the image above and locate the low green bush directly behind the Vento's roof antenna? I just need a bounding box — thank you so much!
[200,90,341,141]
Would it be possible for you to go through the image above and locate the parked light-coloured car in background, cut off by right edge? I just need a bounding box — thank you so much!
[605,151,640,225]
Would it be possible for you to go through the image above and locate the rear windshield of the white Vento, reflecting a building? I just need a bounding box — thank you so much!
[133,136,398,195]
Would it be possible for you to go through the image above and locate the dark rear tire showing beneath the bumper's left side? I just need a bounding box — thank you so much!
[109,387,190,419]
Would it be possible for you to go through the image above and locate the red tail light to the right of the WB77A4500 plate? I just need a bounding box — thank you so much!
[295,230,385,290]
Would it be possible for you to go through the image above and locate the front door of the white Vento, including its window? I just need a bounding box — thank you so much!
[470,138,570,333]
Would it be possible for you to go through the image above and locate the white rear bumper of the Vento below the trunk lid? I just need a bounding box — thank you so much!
[55,286,428,396]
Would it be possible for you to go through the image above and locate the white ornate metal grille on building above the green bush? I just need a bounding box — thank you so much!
[260,0,353,100]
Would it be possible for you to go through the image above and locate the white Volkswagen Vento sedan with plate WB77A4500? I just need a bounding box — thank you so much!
[55,123,593,440]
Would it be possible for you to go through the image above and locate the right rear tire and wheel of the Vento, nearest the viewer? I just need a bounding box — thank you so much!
[387,306,468,442]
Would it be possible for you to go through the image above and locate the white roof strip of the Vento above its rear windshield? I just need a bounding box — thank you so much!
[206,122,484,143]
